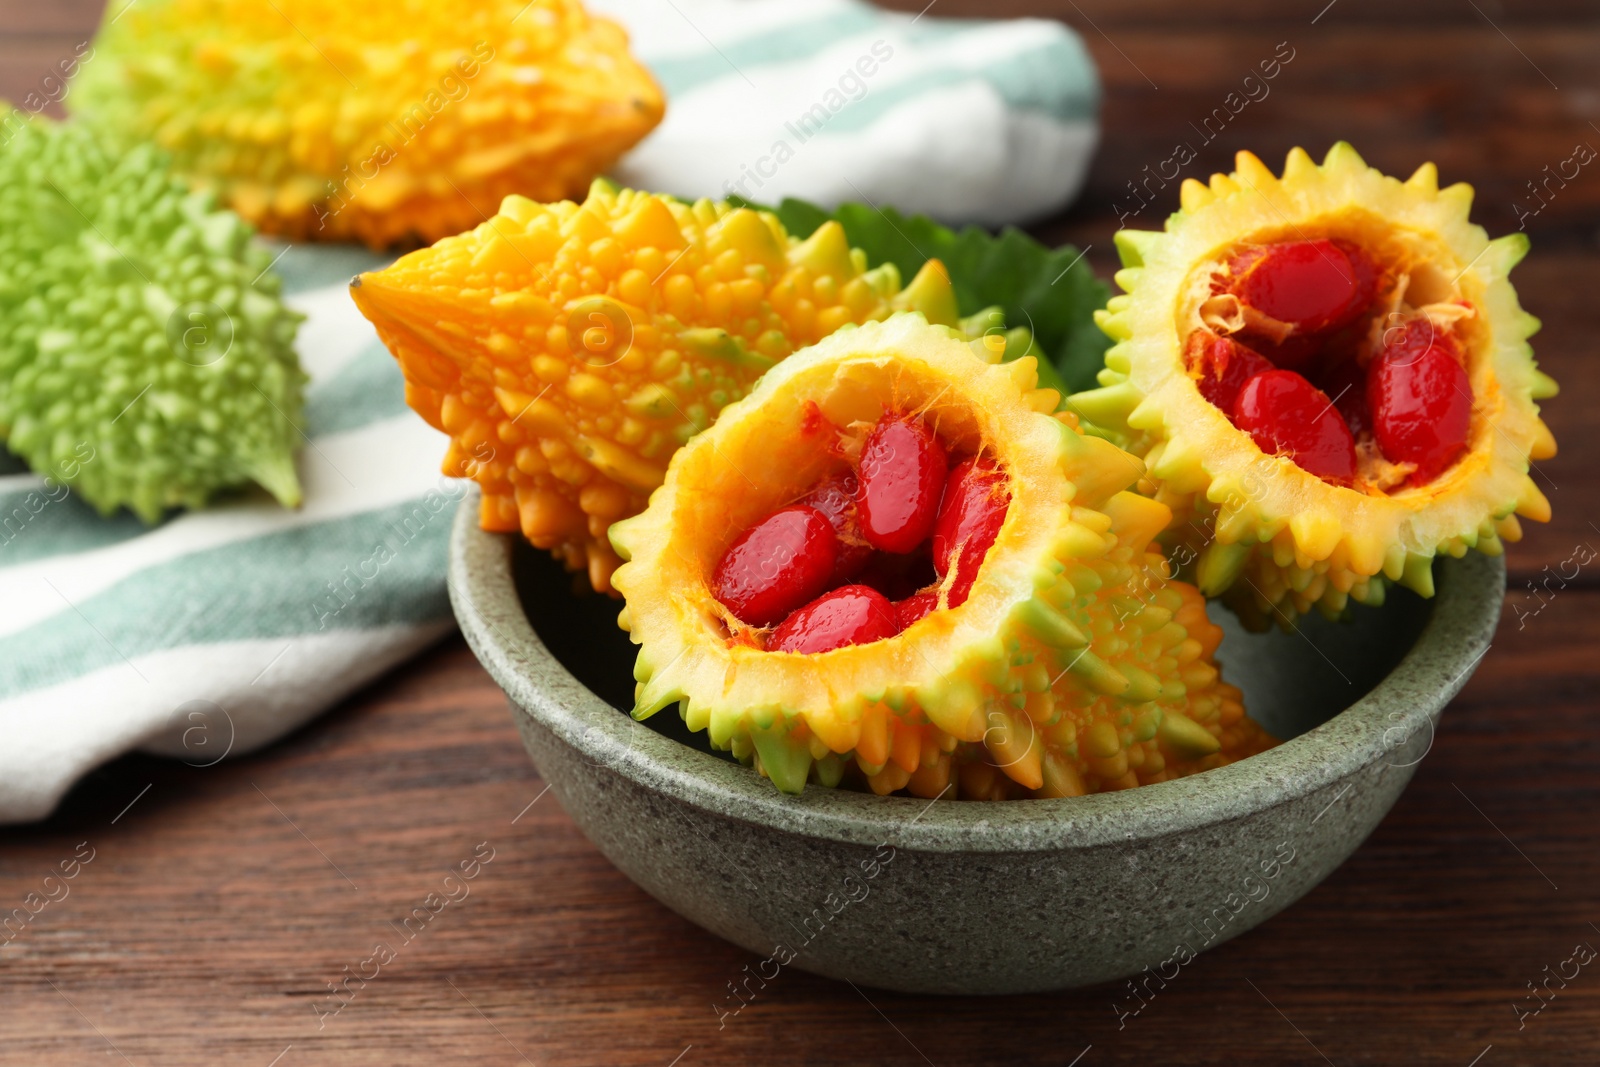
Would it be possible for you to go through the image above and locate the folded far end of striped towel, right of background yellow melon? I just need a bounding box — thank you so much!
[589,0,1099,226]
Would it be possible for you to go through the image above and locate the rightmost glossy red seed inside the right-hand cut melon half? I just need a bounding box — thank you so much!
[1366,320,1472,485]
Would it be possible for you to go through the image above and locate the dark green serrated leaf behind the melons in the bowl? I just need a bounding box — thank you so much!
[736,198,1110,390]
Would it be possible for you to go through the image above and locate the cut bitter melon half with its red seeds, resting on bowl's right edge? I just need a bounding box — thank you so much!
[1070,144,1557,625]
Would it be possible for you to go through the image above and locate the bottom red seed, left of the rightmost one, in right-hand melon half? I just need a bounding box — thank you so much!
[1234,371,1355,482]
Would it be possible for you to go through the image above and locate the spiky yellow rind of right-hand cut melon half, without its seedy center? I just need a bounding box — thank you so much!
[1069,142,1557,627]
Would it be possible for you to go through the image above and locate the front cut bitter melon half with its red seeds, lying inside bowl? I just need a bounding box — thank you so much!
[611,314,1272,798]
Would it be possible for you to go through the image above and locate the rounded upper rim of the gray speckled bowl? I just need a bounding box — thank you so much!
[450,486,1506,853]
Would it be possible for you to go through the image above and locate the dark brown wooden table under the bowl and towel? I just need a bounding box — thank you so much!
[0,0,1600,1067]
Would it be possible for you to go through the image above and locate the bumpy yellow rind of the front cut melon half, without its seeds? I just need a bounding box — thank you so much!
[611,315,1267,797]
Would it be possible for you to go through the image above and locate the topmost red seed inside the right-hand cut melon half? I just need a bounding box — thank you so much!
[1229,240,1374,333]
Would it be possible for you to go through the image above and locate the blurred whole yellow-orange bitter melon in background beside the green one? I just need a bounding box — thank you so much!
[67,0,664,248]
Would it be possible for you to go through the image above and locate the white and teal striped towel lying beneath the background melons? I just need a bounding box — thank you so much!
[0,0,1098,822]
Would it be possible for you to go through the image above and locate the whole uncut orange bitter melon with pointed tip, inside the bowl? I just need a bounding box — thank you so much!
[350,182,953,590]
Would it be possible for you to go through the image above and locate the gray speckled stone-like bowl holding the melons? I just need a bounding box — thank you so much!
[450,494,1506,991]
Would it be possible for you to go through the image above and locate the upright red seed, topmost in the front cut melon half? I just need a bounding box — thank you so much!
[858,414,947,552]
